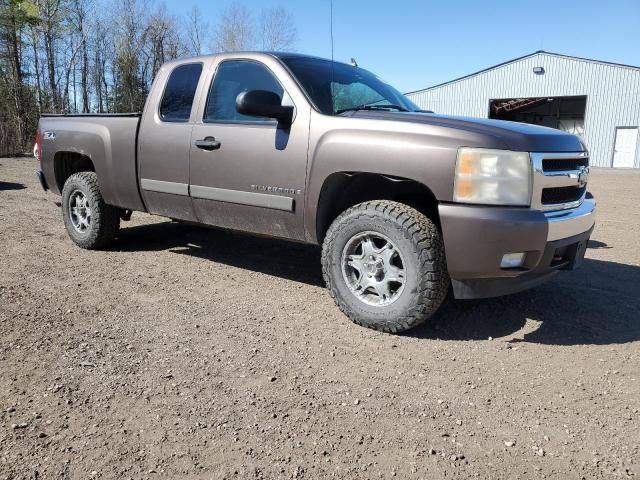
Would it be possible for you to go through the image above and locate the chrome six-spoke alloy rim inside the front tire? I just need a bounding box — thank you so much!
[341,232,406,307]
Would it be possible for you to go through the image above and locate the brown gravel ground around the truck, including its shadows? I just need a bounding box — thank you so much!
[0,158,640,479]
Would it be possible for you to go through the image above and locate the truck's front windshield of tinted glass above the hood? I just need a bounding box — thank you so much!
[282,57,420,115]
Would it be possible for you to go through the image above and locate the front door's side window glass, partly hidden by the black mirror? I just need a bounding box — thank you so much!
[204,60,284,123]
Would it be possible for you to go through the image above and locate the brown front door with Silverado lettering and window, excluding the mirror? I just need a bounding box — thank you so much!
[190,58,310,239]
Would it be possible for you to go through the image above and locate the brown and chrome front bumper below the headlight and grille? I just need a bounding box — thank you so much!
[439,196,596,299]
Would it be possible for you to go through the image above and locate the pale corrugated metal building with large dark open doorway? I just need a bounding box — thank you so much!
[407,51,640,168]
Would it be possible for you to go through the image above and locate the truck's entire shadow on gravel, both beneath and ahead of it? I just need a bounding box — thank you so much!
[114,222,640,345]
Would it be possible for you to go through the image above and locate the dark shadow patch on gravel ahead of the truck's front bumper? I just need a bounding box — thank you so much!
[407,258,640,345]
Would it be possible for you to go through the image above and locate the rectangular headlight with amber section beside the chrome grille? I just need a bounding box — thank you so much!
[453,147,531,206]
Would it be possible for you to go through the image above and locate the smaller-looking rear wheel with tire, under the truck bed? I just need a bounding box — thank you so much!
[62,172,120,250]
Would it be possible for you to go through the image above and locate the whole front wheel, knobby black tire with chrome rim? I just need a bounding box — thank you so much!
[322,200,450,333]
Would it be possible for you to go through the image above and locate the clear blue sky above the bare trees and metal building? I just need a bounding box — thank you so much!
[165,0,640,92]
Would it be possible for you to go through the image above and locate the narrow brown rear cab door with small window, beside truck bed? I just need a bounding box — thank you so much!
[138,62,204,221]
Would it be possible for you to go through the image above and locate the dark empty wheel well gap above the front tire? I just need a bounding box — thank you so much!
[316,172,440,243]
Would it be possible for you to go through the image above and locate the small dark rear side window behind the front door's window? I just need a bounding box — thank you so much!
[160,63,202,122]
